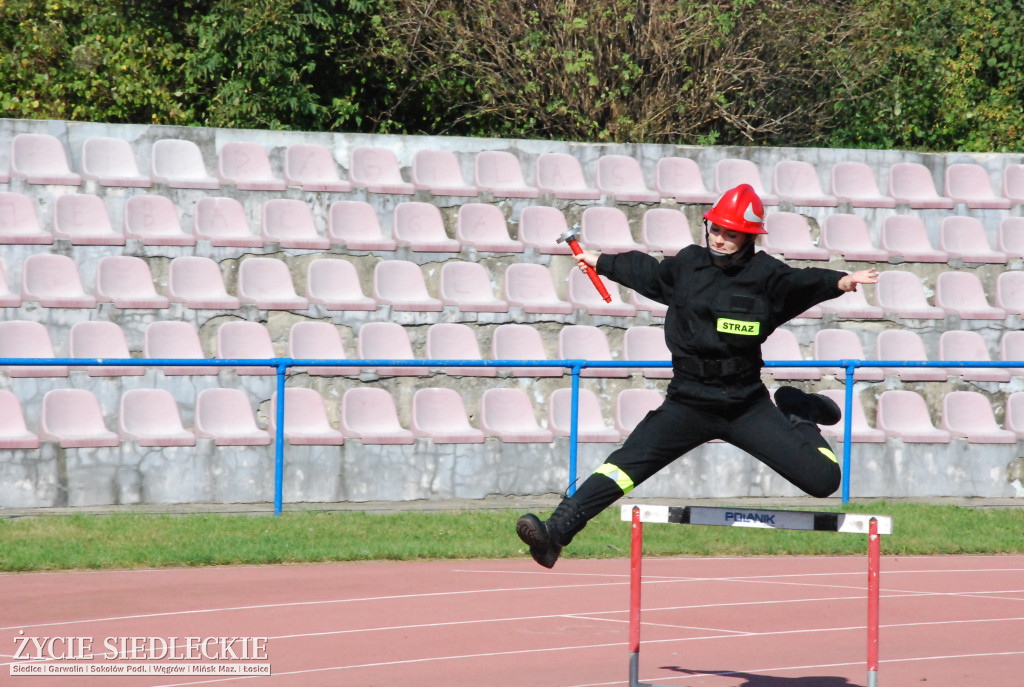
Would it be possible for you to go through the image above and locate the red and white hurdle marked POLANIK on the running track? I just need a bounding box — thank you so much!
[622,504,892,687]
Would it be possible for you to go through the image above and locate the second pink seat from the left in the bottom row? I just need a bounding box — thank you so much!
[39,389,121,448]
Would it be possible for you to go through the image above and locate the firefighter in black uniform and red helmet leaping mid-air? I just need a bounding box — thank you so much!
[516,183,878,568]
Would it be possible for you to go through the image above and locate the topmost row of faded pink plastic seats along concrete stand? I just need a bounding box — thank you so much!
[0,134,1024,209]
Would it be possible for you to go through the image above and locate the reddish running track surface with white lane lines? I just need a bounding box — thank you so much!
[0,555,1024,687]
